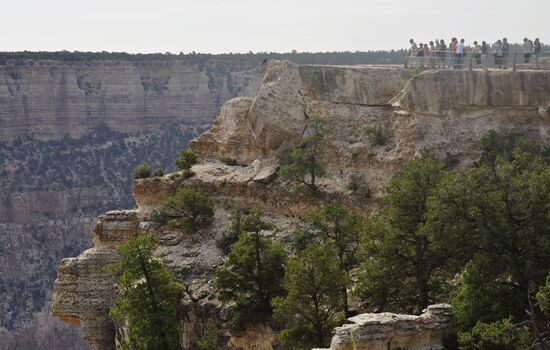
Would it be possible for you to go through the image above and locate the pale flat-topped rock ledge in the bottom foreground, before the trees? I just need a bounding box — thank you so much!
[330,304,451,350]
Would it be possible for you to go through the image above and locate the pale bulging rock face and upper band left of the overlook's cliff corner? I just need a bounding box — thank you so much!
[190,61,410,164]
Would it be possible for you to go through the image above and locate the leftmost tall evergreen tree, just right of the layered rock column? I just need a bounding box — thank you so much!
[110,236,182,350]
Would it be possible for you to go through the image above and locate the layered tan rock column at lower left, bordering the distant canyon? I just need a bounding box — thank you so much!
[52,211,139,350]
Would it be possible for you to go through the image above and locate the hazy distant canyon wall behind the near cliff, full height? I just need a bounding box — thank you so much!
[0,59,262,350]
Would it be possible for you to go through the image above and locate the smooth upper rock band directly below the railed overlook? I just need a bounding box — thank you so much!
[401,70,550,116]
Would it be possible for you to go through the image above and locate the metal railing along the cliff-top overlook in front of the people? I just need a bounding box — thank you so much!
[405,48,550,71]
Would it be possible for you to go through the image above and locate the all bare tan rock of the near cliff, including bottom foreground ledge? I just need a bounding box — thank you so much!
[52,61,550,349]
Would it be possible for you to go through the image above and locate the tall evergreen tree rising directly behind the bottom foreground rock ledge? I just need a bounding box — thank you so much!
[357,156,451,312]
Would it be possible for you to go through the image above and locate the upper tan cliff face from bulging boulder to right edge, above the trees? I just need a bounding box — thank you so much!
[190,61,550,193]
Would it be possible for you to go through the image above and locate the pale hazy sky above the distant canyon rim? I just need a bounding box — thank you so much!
[0,0,550,53]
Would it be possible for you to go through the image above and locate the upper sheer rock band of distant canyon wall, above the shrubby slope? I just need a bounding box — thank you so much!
[0,60,261,140]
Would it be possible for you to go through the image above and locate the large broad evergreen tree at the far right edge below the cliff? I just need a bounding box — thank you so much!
[430,134,550,346]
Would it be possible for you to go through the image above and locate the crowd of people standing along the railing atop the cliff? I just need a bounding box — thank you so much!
[407,38,542,69]
